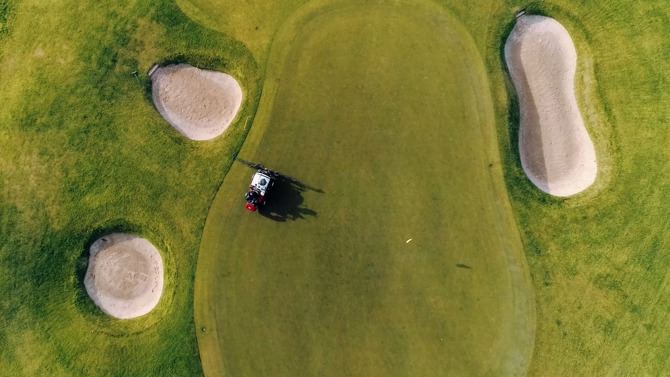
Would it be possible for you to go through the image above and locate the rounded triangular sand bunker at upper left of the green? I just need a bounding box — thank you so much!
[151,64,242,140]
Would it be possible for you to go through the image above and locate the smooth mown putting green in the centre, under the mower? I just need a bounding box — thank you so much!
[195,2,534,376]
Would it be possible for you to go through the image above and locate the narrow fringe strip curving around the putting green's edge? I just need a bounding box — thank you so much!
[194,0,536,376]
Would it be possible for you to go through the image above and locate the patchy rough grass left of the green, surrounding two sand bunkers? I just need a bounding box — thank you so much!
[0,0,260,376]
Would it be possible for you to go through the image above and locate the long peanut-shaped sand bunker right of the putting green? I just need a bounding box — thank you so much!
[505,16,597,196]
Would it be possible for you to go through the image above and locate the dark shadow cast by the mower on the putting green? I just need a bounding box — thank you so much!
[258,180,317,222]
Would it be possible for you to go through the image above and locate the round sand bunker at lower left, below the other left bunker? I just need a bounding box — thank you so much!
[84,233,163,319]
